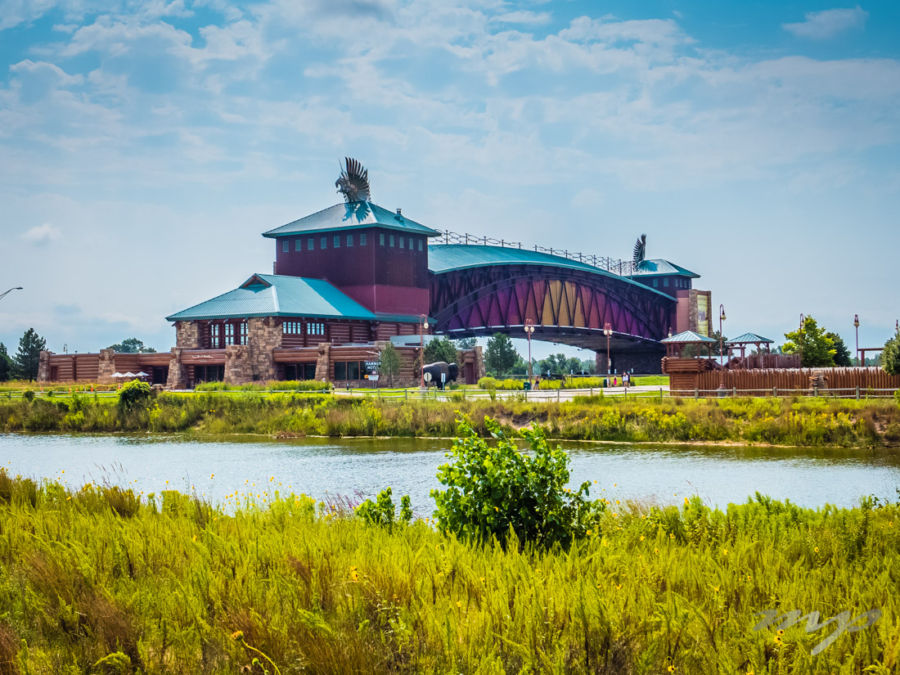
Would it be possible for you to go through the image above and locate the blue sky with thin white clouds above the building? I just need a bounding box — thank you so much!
[0,0,900,364]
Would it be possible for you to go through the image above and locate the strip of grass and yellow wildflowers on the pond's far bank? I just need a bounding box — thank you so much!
[0,392,900,448]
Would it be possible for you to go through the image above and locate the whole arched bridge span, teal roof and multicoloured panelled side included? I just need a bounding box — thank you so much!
[428,244,676,367]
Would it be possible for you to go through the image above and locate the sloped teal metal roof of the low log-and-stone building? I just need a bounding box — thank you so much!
[166,274,419,322]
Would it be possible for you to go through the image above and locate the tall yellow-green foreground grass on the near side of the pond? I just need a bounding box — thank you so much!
[0,472,900,673]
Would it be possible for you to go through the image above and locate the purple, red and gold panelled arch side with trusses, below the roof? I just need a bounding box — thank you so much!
[431,265,675,349]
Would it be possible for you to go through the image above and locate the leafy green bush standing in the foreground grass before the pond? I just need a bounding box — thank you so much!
[431,417,603,547]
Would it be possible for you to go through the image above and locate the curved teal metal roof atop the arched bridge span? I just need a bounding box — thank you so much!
[428,244,673,300]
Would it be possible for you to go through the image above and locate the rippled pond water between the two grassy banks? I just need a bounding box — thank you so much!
[0,434,900,514]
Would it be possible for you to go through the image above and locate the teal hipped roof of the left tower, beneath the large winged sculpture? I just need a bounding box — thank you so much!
[263,202,441,238]
